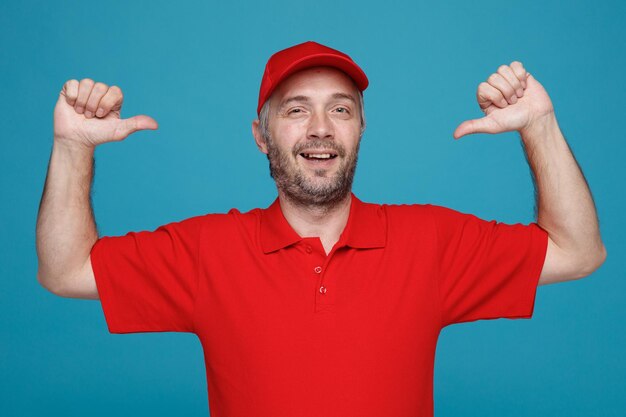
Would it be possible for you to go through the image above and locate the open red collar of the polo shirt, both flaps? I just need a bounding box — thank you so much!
[260,193,387,253]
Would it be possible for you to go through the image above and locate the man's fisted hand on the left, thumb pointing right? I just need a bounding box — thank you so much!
[54,78,158,148]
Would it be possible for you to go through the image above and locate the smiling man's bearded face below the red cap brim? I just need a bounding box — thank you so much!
[252,67,361,206]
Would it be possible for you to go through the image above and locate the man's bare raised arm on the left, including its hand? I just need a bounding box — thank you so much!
[36,78,158,299]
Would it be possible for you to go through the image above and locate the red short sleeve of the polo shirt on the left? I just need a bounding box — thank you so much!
[91,216,203,333]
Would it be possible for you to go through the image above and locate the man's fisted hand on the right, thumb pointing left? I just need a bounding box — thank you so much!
[453,61,554,139]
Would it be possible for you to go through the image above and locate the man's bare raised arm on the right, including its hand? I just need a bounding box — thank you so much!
[454,61,606,285]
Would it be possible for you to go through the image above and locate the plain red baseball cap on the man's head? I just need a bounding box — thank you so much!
[256,41,369,115]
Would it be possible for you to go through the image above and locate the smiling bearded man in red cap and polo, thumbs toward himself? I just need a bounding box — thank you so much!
[37,42,606,417]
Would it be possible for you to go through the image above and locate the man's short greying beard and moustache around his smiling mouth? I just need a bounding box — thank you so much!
[266,136,361,209]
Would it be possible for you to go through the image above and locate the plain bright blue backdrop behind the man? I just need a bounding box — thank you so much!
[0,0,626,417]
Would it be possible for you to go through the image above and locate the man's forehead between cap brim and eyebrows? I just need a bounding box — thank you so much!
[272,67,359,104]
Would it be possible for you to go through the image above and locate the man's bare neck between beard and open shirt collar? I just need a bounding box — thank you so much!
[278,190,352,254]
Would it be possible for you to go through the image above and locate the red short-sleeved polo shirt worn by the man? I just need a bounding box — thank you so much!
[91,195,548,417]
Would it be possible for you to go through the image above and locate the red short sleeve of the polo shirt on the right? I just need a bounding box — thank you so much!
[428,205,548,327]
